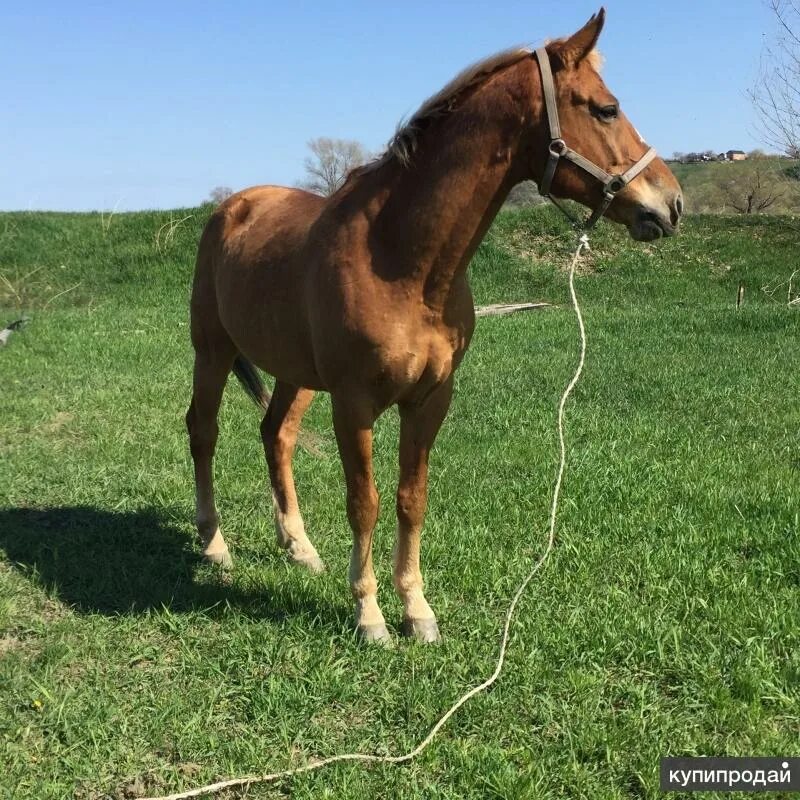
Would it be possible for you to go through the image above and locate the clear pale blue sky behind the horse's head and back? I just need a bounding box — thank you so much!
[0,0,775,210]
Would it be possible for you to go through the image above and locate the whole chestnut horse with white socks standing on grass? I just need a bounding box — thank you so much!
[186,10,682,641]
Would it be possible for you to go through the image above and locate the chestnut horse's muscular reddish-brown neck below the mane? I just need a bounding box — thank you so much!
[373,64,535,310]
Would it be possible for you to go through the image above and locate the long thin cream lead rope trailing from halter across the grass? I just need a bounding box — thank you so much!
[143,233,590,800]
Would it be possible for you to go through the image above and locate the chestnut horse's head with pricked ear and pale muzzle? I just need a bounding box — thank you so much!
[532,9,683,241]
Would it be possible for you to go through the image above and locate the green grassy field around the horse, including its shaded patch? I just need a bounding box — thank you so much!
[0,208,800,800]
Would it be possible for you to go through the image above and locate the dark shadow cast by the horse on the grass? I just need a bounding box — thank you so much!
[0,506,347,631]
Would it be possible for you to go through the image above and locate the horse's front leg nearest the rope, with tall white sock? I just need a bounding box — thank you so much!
[394,375,453,642]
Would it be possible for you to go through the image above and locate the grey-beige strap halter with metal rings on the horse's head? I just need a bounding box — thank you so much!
[536,47,656,231]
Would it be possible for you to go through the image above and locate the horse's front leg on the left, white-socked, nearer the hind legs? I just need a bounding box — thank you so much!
[332,393,390,642]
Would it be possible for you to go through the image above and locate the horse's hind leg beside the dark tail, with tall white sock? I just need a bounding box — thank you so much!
[261,381,325,572]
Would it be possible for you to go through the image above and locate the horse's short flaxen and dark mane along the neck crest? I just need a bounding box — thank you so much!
[351,39,603,176]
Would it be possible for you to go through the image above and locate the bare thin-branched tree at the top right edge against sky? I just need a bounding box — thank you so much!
[750,0,800,158]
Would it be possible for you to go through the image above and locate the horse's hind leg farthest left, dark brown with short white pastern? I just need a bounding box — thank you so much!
[186,319,236,566]
